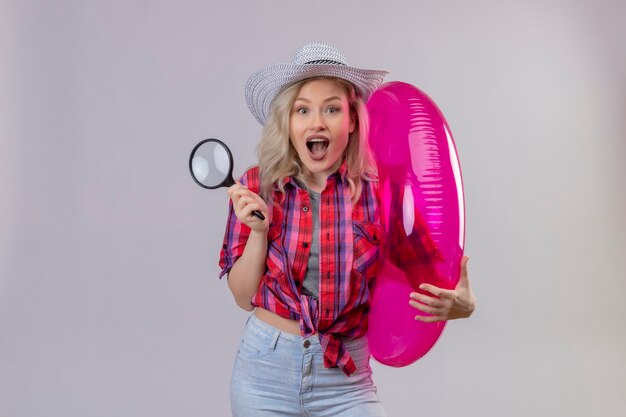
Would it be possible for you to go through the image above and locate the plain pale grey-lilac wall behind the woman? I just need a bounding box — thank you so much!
[0,0,626,417]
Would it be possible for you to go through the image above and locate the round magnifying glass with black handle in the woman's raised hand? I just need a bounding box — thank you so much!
[189,138,265,220]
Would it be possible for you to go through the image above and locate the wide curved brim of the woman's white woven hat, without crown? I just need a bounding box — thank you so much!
[246,64,389,125]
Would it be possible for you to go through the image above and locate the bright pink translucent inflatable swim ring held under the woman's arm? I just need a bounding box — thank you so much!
[367,82,465,367]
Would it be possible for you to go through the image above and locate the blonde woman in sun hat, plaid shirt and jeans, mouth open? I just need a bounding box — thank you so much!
[220,43,475,417]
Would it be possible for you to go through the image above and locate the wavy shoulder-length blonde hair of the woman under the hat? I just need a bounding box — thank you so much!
[258,77,376,202]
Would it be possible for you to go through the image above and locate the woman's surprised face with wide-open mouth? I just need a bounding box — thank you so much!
[289,79,355,184]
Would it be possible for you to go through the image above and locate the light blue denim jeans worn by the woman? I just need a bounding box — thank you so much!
[230,314,385,417]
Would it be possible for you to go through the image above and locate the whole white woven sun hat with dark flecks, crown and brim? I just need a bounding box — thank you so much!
[246,42,389,125]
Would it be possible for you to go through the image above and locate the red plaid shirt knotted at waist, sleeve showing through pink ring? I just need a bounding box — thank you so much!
[220,163,436,375]
